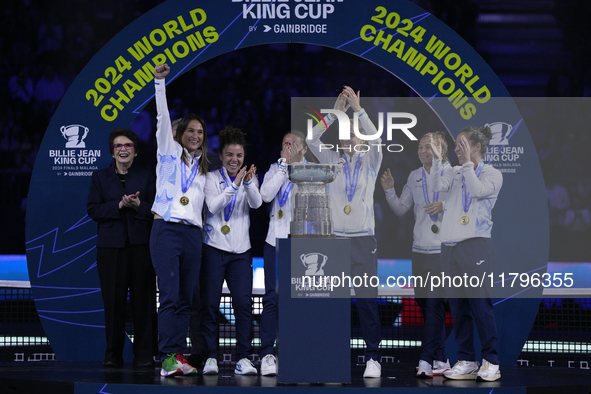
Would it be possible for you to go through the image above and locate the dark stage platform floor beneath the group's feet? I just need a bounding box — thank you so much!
[0,360,591,394]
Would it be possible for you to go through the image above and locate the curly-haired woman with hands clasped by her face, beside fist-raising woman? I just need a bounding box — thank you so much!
[200,126,263,375]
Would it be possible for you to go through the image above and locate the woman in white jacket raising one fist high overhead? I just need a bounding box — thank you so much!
[150,64,207,376]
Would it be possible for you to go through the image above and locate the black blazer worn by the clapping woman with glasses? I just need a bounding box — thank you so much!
[86,160,156,248]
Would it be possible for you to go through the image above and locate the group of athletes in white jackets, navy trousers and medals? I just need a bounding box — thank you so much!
[89,64,502,381]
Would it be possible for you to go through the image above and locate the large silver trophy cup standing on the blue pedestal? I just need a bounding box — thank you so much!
[288,163,341,238]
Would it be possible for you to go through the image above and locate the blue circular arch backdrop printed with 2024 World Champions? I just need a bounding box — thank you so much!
[26,0,549,364]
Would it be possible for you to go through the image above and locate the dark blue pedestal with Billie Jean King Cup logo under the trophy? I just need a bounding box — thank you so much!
[276,236,351,384]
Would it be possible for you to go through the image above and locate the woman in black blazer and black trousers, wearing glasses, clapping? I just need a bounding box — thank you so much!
[87,128,158,367]
